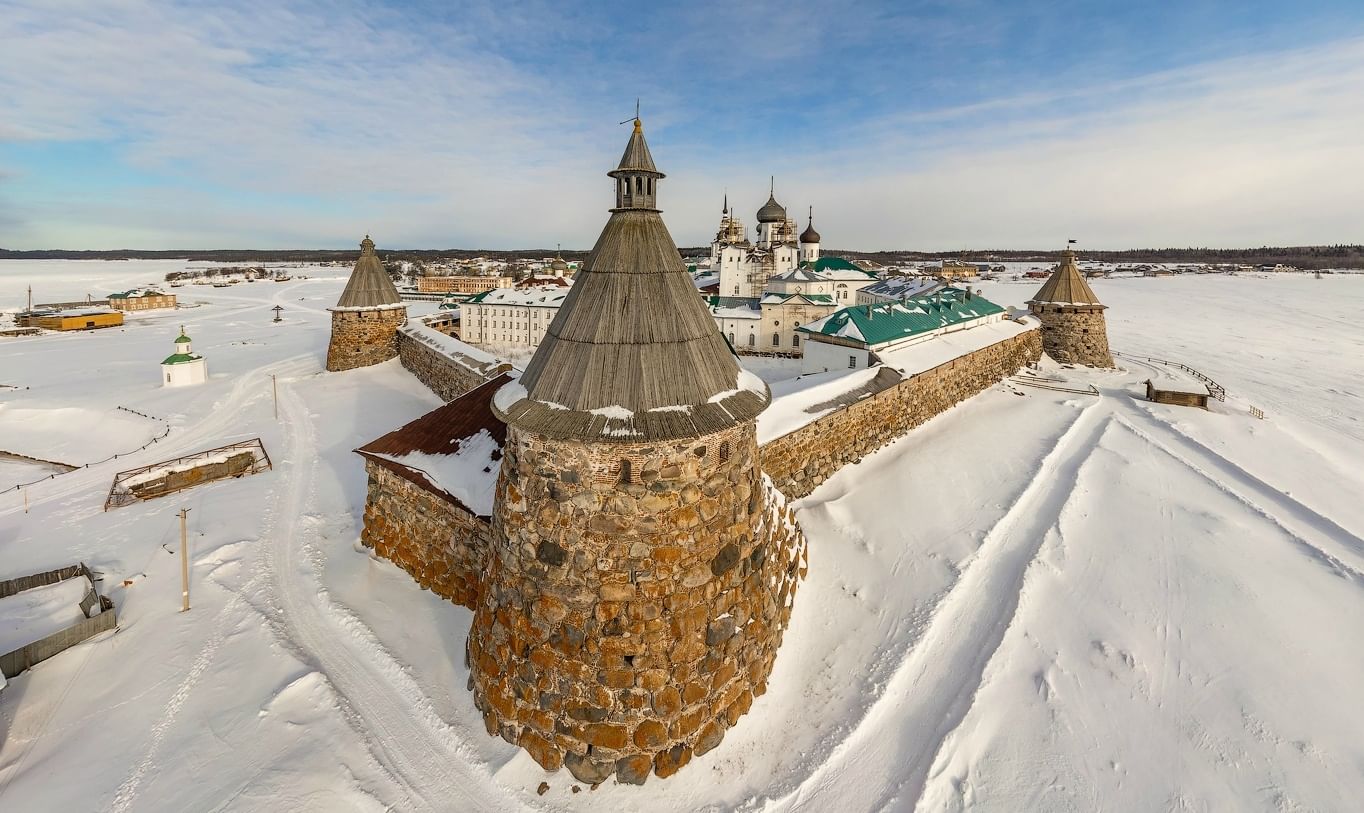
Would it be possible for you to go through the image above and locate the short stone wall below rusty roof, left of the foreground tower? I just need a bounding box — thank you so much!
[360,458,492,607]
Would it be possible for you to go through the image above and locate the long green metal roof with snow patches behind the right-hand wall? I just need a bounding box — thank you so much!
[797,288,1004,346]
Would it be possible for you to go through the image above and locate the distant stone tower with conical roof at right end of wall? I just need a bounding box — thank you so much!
[1027,244,1113,367]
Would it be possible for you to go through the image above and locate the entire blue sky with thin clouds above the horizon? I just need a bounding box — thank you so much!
[0,0,1364,251]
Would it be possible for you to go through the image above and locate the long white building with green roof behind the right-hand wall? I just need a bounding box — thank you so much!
[797,288,1008,372]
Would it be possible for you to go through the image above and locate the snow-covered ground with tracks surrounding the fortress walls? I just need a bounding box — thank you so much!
[0,262,1364,812]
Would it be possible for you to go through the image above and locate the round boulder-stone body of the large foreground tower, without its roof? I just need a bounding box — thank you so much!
[468,422,807,784]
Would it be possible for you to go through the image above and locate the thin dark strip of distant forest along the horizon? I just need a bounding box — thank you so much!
[0,244,1364,270]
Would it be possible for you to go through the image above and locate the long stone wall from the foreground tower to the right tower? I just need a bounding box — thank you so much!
[761,330,1042,499]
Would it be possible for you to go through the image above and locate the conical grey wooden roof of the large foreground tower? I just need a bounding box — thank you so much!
[494,120,771,443]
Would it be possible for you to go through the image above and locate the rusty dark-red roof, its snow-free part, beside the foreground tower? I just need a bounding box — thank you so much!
[356,372,512,516]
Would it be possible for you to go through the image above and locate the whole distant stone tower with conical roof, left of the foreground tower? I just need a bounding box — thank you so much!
[327,235,408,372]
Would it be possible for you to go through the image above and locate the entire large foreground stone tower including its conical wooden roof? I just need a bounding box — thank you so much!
[468,120,806,783]
